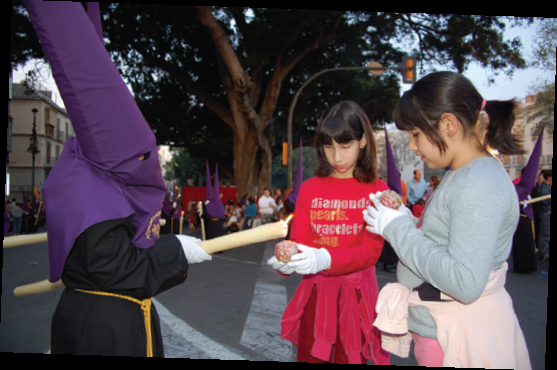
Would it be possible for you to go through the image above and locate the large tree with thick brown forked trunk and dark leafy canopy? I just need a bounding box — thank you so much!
[11,3,532,194]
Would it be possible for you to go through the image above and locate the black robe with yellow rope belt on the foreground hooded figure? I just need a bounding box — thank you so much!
[51,219,188,357]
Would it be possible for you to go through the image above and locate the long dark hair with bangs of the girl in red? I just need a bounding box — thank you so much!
[314,100,377,183]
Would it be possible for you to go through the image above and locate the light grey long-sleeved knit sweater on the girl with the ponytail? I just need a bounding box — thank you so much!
[384,157,519,338]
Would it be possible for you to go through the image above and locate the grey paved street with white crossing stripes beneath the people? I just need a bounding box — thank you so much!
[0,231,549,370]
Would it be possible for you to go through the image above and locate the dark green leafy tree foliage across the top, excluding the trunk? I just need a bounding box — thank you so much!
[10,5,533,185]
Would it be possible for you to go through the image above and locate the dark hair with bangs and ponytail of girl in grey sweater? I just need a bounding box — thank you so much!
[393,72,525,154]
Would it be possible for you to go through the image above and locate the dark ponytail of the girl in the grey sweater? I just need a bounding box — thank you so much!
[484,100,525,155]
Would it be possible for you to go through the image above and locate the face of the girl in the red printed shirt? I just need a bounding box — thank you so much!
[323,136,366,179]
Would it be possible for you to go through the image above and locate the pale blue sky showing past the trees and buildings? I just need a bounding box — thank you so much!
[14,16,555,107]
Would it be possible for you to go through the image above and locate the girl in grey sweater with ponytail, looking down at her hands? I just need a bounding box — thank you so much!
[364,72,523,366]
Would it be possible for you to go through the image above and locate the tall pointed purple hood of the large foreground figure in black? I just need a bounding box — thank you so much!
[24,1,165,282]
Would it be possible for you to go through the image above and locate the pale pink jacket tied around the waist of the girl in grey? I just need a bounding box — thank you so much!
[373,263,532,369]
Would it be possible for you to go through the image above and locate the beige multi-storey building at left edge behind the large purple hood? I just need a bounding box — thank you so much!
[6,84,75,200]
